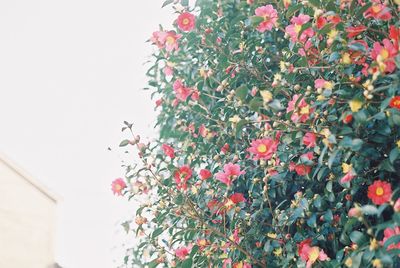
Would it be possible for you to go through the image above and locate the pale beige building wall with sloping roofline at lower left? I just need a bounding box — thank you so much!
[0,158,56,268]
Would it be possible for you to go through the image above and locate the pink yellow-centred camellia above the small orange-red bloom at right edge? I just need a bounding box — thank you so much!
[371,39,398,73]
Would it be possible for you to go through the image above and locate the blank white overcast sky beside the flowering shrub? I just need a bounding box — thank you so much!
[0,0,174,268]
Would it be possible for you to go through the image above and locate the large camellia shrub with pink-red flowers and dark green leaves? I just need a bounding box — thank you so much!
[113,0,400,267]
